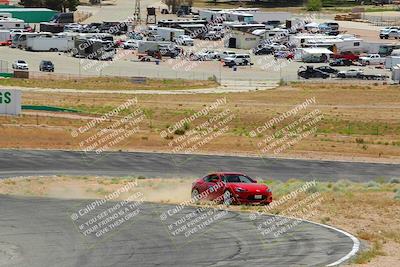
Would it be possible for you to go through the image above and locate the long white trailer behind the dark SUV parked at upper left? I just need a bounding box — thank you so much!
[26,36,75,52]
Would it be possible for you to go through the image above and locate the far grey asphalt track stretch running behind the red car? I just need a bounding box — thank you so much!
[0,150,400,182]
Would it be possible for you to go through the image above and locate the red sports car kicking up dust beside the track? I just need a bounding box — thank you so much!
[192,172,272,205]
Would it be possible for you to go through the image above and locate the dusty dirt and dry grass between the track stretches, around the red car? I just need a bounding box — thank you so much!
[0,176,400,267]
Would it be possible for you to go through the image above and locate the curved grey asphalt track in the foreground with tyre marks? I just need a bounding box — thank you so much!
[0,196,354,267]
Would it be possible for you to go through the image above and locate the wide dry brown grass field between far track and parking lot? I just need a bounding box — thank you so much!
[0,82,400,163]
